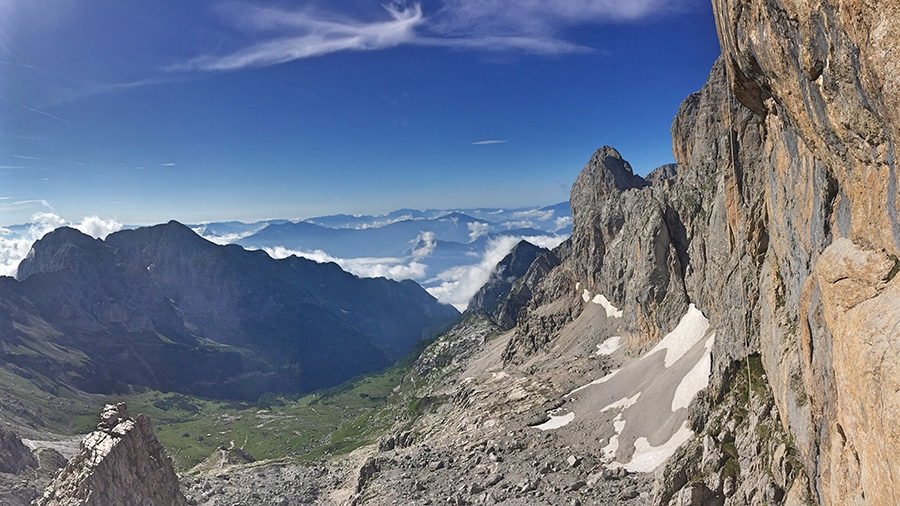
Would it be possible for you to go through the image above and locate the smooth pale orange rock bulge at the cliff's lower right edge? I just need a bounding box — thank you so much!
[815,239,900,504]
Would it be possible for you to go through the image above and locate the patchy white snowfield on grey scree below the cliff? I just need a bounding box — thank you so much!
[537,304,715,473]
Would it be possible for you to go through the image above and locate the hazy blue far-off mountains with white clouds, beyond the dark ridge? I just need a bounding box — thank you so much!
[192,202,572,310]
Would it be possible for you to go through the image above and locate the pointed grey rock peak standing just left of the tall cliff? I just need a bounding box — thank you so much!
[519,146,689,352]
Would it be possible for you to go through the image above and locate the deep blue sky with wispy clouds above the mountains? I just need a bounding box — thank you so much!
[0,0,719,226]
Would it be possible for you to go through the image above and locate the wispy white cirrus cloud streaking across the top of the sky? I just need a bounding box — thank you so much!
[168,0,699,71]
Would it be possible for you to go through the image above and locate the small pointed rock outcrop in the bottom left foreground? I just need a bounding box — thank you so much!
[34,402,188,506]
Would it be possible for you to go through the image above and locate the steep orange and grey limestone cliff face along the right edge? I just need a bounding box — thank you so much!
[713,0,900,504]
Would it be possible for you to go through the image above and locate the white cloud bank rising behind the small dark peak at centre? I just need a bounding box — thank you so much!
[427,235,566,311]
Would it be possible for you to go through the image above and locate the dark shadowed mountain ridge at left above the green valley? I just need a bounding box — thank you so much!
[0,222,459,400]
